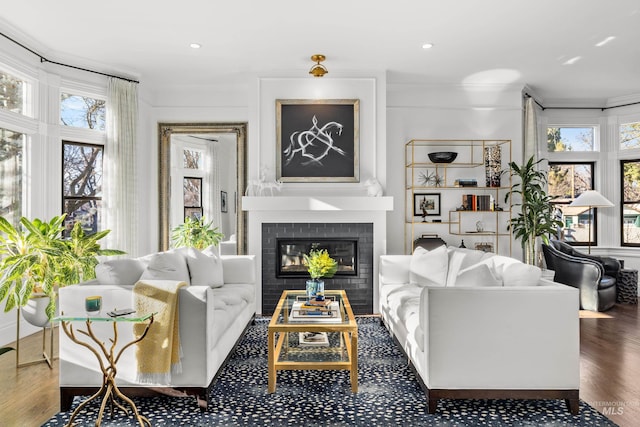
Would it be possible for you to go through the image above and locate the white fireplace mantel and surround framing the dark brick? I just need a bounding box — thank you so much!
[241,196,393,312]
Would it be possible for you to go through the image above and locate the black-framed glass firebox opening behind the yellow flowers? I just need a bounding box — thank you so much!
[276,239,358,278]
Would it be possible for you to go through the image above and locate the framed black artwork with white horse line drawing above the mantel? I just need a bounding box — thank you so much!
[276,99,360,182]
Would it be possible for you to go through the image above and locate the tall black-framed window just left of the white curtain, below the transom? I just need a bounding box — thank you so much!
[62,141,104,237]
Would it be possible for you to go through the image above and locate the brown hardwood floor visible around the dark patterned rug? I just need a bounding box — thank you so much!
[0,304,640,427]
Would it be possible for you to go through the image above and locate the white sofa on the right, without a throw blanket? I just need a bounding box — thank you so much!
[379,246,580,414]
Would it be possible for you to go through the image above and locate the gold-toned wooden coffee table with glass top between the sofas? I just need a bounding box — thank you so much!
[268,290,358,393]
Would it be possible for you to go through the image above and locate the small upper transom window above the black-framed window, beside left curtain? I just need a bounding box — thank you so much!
[60,93,106,131]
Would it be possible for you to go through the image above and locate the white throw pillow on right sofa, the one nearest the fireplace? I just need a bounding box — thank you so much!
[409,245,449,286]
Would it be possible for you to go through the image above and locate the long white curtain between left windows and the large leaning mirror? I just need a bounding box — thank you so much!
[103,77,138,256]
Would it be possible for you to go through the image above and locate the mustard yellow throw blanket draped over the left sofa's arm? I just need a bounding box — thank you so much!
[133,280,187,384]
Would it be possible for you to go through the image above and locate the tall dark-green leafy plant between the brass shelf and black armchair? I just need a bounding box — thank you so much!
[504,156,563,265]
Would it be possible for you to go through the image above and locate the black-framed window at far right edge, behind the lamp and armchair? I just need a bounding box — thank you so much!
[620,159,640,246]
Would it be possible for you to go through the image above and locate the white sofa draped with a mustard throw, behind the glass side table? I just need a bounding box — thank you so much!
[59,248,256,410]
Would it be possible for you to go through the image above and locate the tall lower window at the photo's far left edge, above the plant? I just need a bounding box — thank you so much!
[0,128,26,226]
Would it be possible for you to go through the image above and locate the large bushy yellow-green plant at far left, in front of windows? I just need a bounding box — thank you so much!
[0,214,124,326]
